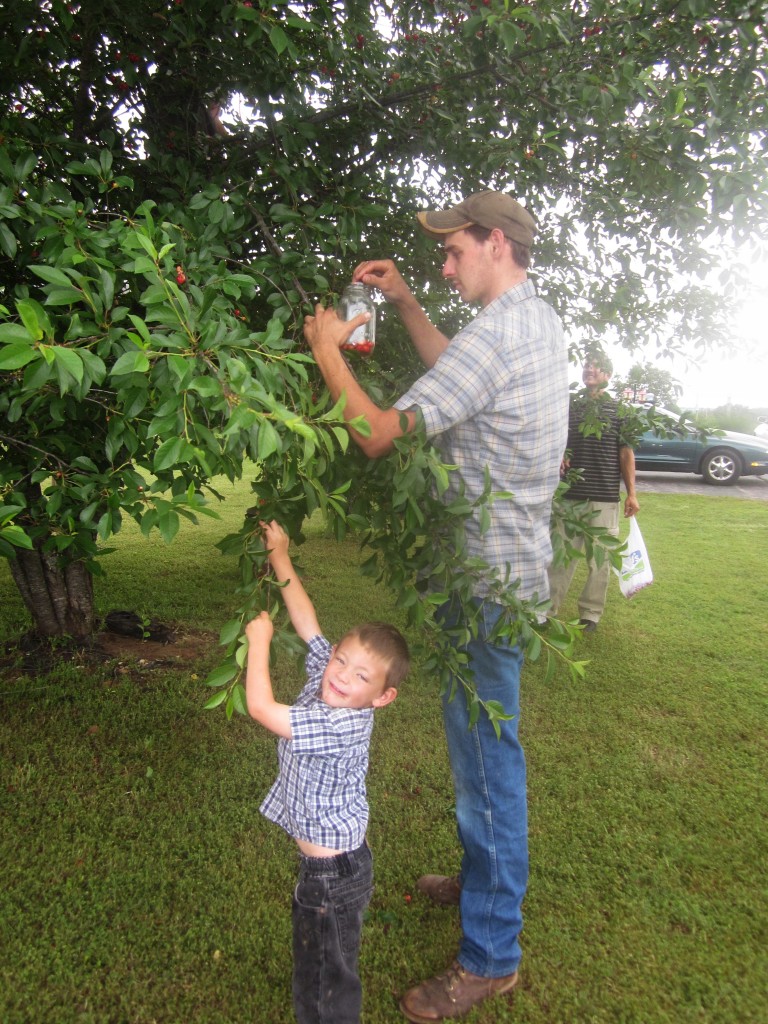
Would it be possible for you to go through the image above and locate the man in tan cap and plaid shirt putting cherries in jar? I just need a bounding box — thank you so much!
[304,191,568,1024]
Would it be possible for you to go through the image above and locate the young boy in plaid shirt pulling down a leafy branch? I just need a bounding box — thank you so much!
[246,522,410,1024]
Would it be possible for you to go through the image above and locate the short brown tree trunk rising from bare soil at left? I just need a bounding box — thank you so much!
[9,548,94,640]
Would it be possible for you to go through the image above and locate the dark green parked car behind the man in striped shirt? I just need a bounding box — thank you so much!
[635,408,768,486]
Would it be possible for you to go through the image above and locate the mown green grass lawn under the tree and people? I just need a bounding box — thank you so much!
[0,486,768,1024]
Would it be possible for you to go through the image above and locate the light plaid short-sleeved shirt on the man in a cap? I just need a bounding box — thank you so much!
[395,281,568,599]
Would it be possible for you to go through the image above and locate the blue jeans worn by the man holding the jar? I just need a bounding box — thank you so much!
[442,602,528,978]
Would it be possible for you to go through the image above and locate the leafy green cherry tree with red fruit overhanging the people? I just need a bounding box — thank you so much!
[0,0,768,698]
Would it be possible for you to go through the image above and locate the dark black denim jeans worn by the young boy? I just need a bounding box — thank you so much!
[293,843,374,1024]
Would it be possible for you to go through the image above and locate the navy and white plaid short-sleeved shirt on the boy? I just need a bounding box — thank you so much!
[261,636,374,853]
